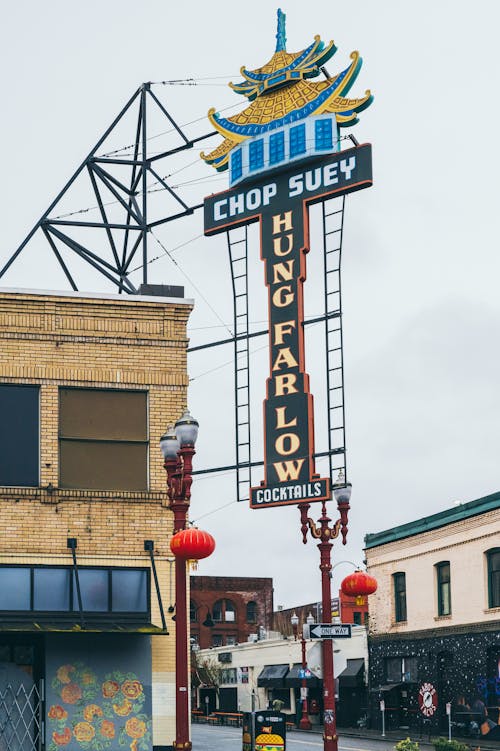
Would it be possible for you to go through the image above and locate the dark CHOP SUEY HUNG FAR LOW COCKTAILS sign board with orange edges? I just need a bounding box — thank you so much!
[204,144,372,508]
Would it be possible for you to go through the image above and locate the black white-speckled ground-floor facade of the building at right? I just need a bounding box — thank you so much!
[369,622,500,739]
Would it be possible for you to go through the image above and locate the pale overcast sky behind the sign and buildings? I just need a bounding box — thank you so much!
[0,0,500,606]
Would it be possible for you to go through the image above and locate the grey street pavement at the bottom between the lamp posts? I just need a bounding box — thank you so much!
[191,725,394,751]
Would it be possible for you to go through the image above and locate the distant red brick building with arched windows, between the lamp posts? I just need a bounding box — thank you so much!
[190,576,273,649]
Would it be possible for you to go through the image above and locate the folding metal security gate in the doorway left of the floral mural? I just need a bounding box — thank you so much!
[0,676,43,751]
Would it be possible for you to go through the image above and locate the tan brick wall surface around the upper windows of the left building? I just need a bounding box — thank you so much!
[0,291,192,745]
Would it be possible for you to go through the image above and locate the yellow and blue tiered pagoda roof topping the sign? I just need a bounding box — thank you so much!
[201,9,372,176]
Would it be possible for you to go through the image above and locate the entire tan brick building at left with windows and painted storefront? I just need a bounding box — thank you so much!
[0,290,192,751]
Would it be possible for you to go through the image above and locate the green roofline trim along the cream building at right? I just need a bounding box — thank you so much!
[365,491,500,549]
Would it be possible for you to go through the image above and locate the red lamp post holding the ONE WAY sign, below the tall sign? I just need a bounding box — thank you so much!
[299,470,351,751]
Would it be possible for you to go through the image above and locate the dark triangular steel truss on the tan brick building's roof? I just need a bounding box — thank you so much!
[0,83,214,294]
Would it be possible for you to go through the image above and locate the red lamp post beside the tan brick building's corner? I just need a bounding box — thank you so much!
[160,409,198,751]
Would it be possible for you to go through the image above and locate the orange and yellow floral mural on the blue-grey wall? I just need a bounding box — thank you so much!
[47,661,152,751]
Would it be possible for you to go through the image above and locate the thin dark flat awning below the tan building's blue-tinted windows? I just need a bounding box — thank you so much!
[0,620,168,635]
